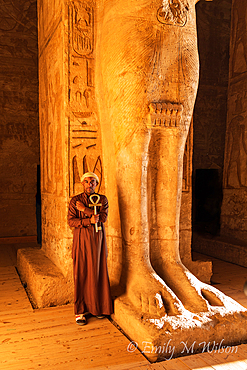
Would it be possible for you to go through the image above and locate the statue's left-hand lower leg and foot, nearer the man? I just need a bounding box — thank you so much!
[114,130,181,315]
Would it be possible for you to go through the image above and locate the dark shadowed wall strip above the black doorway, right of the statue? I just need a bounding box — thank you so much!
[193,0,231,174]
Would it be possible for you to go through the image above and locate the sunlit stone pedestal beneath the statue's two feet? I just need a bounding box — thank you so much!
[112,296,247,362]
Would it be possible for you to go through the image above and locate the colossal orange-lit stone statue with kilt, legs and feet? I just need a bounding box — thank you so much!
[96,0,247,360]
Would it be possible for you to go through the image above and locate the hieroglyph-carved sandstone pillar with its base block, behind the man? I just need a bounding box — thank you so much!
[18,0,109,307]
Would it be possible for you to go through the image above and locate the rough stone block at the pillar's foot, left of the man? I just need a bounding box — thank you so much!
[17,248,73,308]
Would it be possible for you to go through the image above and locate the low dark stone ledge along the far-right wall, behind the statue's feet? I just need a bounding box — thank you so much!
[192,235,247,268]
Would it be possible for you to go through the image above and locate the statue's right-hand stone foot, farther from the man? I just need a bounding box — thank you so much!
[152,261,223,313]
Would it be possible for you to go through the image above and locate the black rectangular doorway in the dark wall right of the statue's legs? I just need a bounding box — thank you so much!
[193,169,222,235]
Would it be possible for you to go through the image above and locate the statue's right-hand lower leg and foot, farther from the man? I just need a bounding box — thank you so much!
[150,127,222,312]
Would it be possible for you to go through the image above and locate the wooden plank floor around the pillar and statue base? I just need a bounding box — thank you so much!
[0,245,247,370]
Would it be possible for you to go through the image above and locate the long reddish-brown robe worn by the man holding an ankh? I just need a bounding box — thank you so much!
[68,193,113,315]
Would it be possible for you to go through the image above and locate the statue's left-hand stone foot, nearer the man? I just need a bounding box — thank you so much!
[127,269,181,316]
